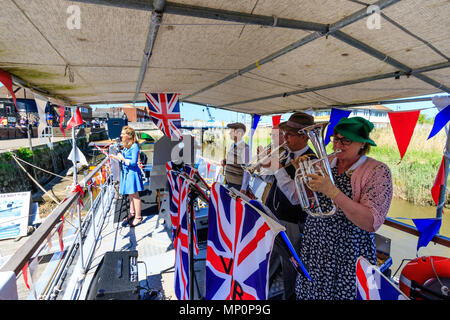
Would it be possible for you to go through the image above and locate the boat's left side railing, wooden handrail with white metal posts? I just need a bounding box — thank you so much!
[0,158,112,299]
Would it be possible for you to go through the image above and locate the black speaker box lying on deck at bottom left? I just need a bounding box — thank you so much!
[87,251,140,300]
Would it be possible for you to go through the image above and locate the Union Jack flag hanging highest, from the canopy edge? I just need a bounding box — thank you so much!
[145,93,181,139]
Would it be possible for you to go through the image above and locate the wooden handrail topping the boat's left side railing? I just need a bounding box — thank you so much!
[0,158,108,276]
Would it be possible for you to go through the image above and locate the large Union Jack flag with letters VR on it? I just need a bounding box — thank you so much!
[205,182,277,300]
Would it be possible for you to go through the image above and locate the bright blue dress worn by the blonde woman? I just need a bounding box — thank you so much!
[119,143,144,194]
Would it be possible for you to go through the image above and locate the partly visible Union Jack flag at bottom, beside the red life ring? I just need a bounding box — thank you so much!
[356,257,409,300]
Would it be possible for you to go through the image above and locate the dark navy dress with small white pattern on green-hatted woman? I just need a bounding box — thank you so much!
[295,167,377,300]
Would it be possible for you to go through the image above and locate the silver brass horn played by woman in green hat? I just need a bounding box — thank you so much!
[294,123,341,217]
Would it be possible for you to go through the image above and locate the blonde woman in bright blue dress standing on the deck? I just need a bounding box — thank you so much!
[111,126,144,227]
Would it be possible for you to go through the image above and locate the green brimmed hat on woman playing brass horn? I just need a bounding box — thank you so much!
[334,117,376,146]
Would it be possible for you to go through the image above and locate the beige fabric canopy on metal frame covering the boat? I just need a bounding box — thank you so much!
[0,0,450,114]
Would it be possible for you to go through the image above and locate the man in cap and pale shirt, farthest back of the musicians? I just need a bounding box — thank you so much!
[222,122,250,193]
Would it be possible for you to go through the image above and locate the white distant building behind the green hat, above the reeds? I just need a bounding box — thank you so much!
[314,105,392,127]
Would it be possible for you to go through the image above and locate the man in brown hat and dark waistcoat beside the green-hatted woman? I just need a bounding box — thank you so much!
[265,112,315,300]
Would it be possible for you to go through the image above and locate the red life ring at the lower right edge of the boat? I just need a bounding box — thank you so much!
[399,256,450,297]
